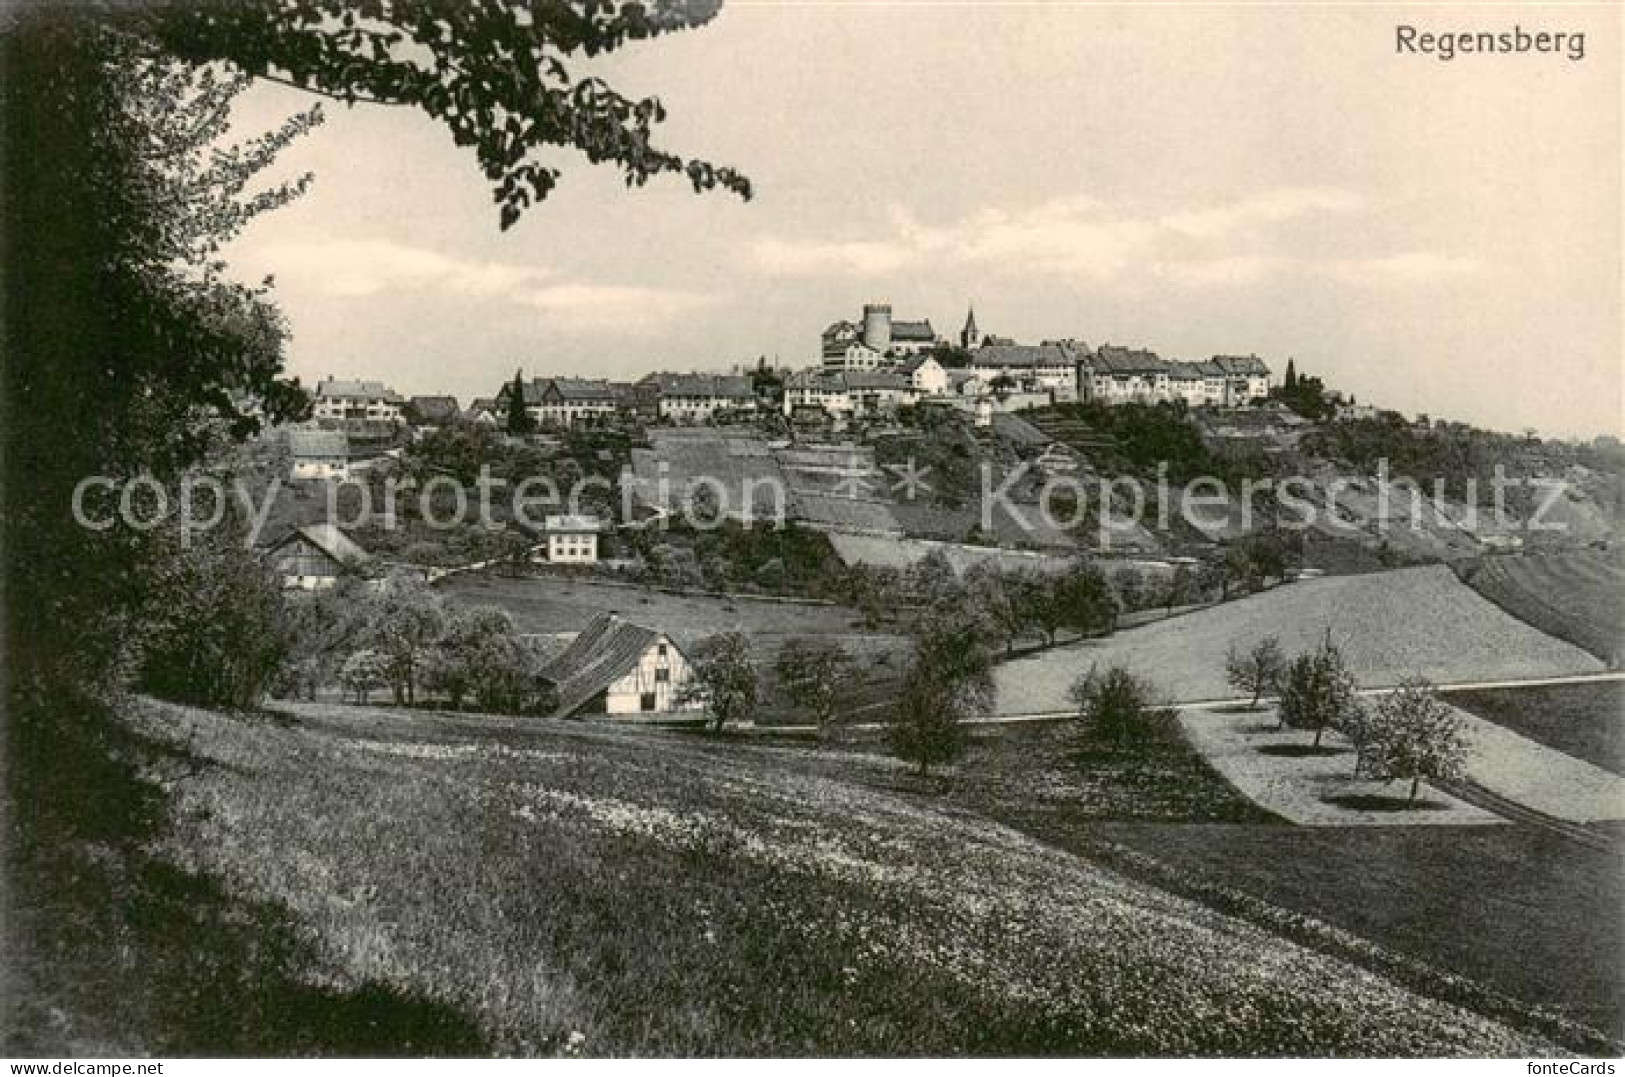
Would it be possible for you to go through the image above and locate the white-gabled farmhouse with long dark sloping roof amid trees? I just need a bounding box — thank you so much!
[541,612,704,718]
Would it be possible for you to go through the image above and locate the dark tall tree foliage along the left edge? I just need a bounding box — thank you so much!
[0,18,319,708]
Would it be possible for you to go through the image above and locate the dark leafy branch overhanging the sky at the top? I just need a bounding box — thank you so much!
[134,0,751,227]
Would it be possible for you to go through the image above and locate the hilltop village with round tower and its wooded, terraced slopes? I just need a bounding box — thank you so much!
[262,302,1614,590]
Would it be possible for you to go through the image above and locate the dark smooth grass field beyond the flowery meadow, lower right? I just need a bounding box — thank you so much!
[1100,824,1625,1036]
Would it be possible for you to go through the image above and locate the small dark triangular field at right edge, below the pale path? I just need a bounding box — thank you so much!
[1448,681,1625,775]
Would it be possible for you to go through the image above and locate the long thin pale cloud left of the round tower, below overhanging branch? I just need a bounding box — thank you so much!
[252,239,710,333]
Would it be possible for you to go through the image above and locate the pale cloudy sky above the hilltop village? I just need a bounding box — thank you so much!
[228,0,1625,437]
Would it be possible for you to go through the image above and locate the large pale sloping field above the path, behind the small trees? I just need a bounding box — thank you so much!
[998,565,1602,713]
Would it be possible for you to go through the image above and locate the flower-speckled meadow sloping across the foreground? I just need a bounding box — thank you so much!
[28,703,1586,1058]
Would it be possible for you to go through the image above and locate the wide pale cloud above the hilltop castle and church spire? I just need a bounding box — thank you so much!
[743,187,1477,289]
